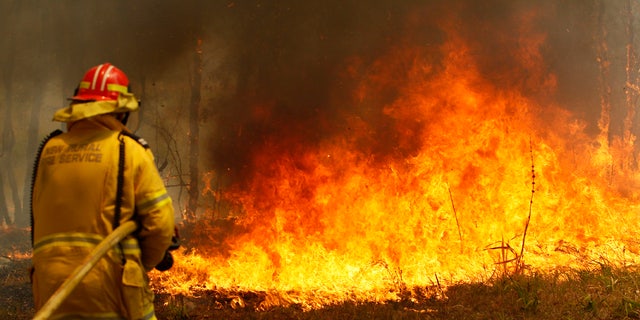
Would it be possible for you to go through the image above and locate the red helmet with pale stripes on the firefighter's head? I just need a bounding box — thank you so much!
[71,63,129,101]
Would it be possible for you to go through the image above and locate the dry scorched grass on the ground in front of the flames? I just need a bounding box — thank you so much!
[0,226,640,320]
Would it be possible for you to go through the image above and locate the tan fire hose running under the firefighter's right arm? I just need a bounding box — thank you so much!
[33,221,137,320]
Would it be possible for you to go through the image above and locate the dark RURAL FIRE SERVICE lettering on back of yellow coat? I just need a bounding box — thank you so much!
[42,143,102,165]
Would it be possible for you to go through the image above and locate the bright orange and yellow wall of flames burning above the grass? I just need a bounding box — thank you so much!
[154,5,640,308]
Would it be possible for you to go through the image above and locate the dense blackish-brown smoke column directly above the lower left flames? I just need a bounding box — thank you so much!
[211,1,448,185]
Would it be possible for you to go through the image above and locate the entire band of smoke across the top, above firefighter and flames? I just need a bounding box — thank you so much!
[0,0,624,202]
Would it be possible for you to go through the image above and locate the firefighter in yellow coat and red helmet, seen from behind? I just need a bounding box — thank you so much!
[31,63,175,319]
